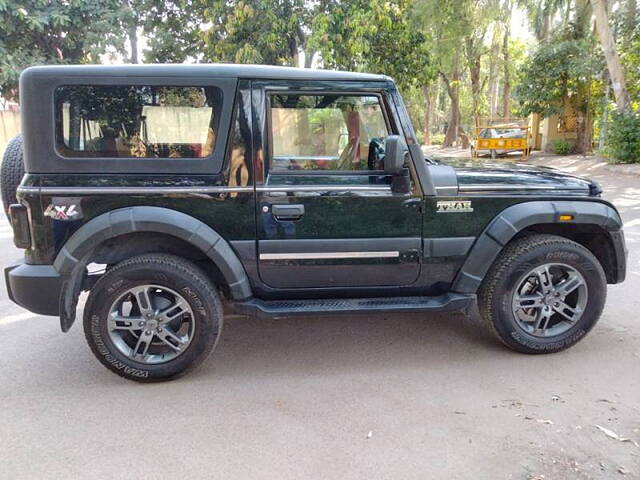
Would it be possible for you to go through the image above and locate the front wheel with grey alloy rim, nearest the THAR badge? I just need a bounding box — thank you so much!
[478,234,607,354]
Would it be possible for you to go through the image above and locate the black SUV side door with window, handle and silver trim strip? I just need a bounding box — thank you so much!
[252,81,422,289]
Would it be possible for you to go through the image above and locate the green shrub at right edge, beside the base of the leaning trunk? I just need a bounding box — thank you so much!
[605,111,640,163]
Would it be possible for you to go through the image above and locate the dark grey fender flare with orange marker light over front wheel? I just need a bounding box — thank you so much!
[451,201,622,293]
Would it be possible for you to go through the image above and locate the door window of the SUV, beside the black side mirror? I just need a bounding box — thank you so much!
[269,94,389,172]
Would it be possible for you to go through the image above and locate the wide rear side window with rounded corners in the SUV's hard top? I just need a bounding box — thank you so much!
[55,85,222,158]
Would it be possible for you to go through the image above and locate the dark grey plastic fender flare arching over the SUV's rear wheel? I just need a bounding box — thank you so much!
[53,206,252,332]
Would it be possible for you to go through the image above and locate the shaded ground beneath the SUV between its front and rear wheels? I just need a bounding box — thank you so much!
[189,314,511,379]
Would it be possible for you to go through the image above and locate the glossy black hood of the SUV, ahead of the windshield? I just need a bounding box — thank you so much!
[439,159,601,195]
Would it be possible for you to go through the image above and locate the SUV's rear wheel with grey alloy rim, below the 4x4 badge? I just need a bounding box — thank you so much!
[84,254,222,382]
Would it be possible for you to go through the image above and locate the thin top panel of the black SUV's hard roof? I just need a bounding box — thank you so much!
[23,63,389,81]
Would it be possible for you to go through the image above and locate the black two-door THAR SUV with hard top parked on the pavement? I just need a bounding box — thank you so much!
[3,65,626,381]
